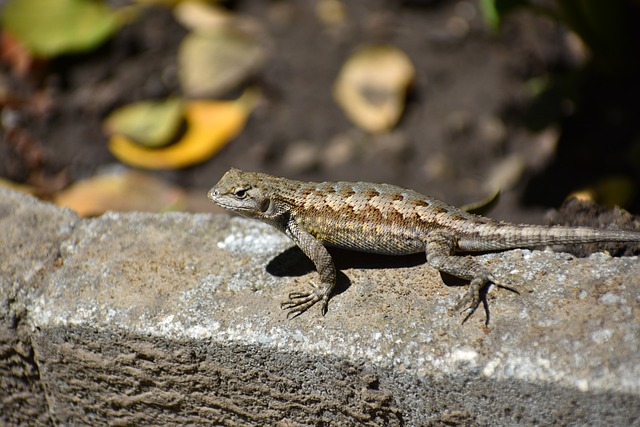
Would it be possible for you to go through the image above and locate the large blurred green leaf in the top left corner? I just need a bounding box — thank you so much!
[2,0,120,57]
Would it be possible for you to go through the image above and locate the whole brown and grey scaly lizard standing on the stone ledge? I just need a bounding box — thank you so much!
[208,168,640,317]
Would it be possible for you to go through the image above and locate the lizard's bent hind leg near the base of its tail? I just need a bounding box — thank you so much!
[426,231,494,314]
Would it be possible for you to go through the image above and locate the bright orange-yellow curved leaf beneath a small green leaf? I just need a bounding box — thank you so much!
[109,89,258,169]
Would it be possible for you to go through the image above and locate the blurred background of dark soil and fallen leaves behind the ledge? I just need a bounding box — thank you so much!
[0,0,640,223]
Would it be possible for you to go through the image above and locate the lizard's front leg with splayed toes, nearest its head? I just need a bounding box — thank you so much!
[280,218,336,318]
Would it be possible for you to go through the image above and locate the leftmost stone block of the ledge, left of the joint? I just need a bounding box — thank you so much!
[0,188,77,426]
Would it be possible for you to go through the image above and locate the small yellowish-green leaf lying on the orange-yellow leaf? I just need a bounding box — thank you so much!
[104,98,184,148]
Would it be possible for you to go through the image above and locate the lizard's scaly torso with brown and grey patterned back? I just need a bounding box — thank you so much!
[263,176,482,255]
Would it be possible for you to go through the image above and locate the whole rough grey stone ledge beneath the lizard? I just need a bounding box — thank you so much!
[0,190,640,426]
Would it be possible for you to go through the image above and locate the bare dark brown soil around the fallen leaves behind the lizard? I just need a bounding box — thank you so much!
[0,0,638,223]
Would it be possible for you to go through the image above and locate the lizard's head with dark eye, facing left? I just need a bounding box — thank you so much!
[207,168,273,219]
